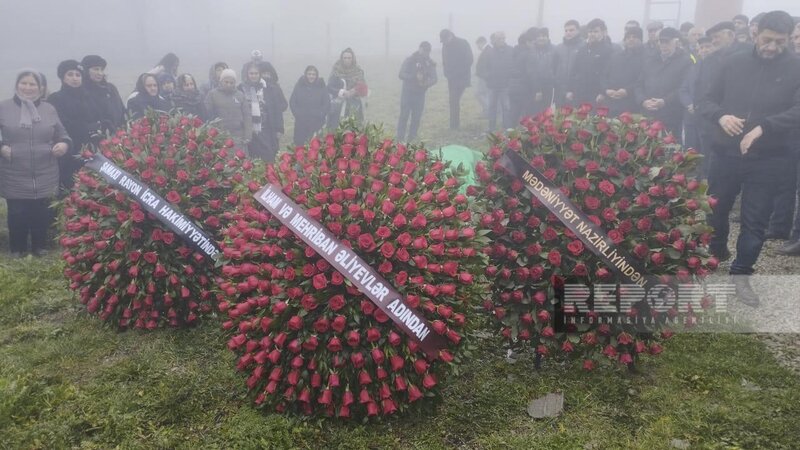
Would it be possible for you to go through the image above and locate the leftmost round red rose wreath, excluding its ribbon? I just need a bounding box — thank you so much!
[60,114,253,329]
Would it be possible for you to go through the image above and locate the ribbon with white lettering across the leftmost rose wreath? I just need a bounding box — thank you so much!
[86,154,220,261]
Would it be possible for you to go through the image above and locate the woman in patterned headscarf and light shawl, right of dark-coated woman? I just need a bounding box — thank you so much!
[328,48,369,128]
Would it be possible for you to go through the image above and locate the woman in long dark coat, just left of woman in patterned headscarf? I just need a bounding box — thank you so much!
[289,66,331,145]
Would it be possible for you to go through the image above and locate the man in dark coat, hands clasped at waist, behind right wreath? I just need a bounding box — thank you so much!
[636,27,692,140]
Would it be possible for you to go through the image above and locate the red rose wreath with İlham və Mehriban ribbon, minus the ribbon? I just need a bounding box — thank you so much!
[219,126,488,418]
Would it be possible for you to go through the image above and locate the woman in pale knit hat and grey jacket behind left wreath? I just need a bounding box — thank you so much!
[205,69,253,151]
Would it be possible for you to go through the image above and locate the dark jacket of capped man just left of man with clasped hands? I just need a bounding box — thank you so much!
[601,47,645,116]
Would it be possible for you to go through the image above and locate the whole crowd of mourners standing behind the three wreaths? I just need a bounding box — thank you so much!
[0,11,800,305]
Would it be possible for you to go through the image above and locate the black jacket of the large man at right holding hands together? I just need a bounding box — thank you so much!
[697,46,800,158]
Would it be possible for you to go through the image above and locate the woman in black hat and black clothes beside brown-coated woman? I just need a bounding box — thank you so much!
[47,59,102,190]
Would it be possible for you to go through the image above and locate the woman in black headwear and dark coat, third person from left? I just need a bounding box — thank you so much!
[81,55,125,132]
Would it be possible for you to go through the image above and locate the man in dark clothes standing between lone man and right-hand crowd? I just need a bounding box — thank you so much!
[439,30,473,130]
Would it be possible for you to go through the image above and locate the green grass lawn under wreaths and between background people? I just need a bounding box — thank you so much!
[0,58,800,449]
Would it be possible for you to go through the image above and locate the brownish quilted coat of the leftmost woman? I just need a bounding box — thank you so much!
[0,97,72,200]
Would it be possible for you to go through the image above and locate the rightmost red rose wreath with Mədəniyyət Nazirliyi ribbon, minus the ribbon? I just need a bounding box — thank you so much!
[468,105,718,370]
